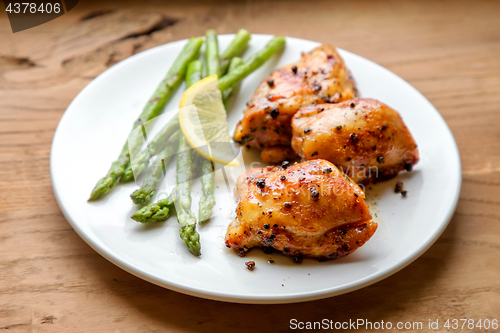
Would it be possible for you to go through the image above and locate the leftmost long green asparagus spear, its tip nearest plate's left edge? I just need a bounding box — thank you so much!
[89,37,203,201]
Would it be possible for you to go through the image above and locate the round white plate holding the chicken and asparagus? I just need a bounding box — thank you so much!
[50,35,461,303]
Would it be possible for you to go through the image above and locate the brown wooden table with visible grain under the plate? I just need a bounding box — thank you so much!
[0,1,500,333]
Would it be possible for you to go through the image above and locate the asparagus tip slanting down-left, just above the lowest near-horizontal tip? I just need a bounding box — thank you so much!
[130,130,181,205]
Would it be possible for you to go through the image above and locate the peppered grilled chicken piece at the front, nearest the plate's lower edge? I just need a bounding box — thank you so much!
[226,160,377,259]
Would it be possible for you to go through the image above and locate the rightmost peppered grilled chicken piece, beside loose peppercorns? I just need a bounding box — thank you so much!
[292,98,418,184]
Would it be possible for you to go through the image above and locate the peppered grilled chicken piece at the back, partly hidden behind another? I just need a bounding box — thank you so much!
[234,45,356,148]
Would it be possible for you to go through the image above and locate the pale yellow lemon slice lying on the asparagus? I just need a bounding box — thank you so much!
[179,75,239,166]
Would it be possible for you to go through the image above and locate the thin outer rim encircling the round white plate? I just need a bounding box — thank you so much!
[50,34,462,304]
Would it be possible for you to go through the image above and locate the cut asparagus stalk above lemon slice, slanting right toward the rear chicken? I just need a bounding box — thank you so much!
[219,36,286,91]
